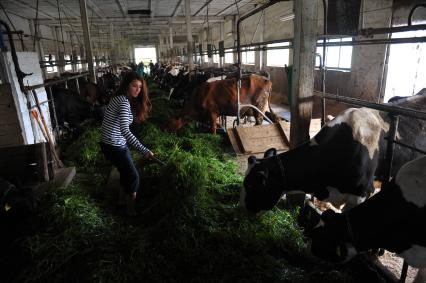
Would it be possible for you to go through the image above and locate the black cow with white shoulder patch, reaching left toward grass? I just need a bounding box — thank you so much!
[240,92,426,212]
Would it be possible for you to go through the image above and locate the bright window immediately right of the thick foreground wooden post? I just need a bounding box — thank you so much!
[315,37,352,71]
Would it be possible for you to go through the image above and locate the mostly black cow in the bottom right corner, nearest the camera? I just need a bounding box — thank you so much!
[308,156,426,283]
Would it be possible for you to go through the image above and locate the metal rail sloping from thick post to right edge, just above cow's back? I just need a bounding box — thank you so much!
[314,90,426,120]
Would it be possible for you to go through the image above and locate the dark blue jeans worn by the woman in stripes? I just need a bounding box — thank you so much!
[100,142,139,194]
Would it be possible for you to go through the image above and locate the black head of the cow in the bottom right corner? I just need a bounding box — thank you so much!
[310,210,356,262]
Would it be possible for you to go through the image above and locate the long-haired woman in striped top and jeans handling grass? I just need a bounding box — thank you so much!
[101,72,154,216]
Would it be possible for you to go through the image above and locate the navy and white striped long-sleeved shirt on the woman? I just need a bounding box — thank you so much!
[101,95,150,155]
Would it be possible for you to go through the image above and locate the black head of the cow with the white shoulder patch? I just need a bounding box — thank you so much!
[240,149,284,213]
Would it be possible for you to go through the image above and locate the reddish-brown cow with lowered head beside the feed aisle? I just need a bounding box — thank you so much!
[165,74,272,133]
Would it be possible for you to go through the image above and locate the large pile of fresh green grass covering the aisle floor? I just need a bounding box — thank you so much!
[3,82,362,282]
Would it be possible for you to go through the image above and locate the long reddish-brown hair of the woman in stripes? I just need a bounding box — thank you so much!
[116,72,152,123]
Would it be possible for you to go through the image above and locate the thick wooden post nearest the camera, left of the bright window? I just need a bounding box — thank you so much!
[290,0,318,148]
